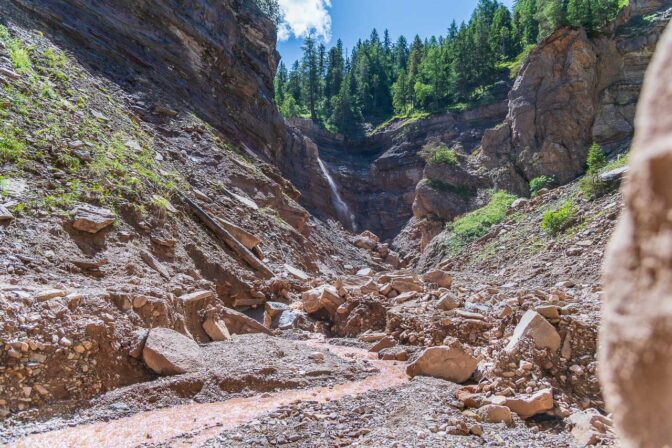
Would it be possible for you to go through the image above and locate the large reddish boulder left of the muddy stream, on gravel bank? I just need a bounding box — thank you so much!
[142,328,204,376]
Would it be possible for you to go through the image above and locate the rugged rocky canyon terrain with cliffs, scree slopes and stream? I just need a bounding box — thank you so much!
[0,0,670,447]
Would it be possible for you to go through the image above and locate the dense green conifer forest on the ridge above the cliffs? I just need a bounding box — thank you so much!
[276,0,624,132]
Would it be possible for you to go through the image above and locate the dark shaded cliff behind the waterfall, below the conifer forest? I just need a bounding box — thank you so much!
[278,102,506,239]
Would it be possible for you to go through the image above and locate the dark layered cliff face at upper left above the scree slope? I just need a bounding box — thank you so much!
[0,0,285,156]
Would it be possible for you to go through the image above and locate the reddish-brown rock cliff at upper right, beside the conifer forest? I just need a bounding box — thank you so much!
[481,2,669,195]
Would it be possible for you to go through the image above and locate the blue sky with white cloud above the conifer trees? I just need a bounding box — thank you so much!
[278,0,513,66]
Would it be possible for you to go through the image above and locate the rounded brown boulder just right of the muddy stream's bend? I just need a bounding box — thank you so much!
[406,343,478,383]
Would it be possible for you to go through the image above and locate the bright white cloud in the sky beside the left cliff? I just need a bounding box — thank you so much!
[278,0,332,41]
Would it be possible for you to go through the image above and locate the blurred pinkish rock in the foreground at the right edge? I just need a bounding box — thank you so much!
[600,20,672,447]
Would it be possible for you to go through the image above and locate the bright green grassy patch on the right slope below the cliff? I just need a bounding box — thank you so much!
[444,191,516,255]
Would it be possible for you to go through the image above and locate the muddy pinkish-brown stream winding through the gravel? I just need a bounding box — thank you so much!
[14,341,408,448]
